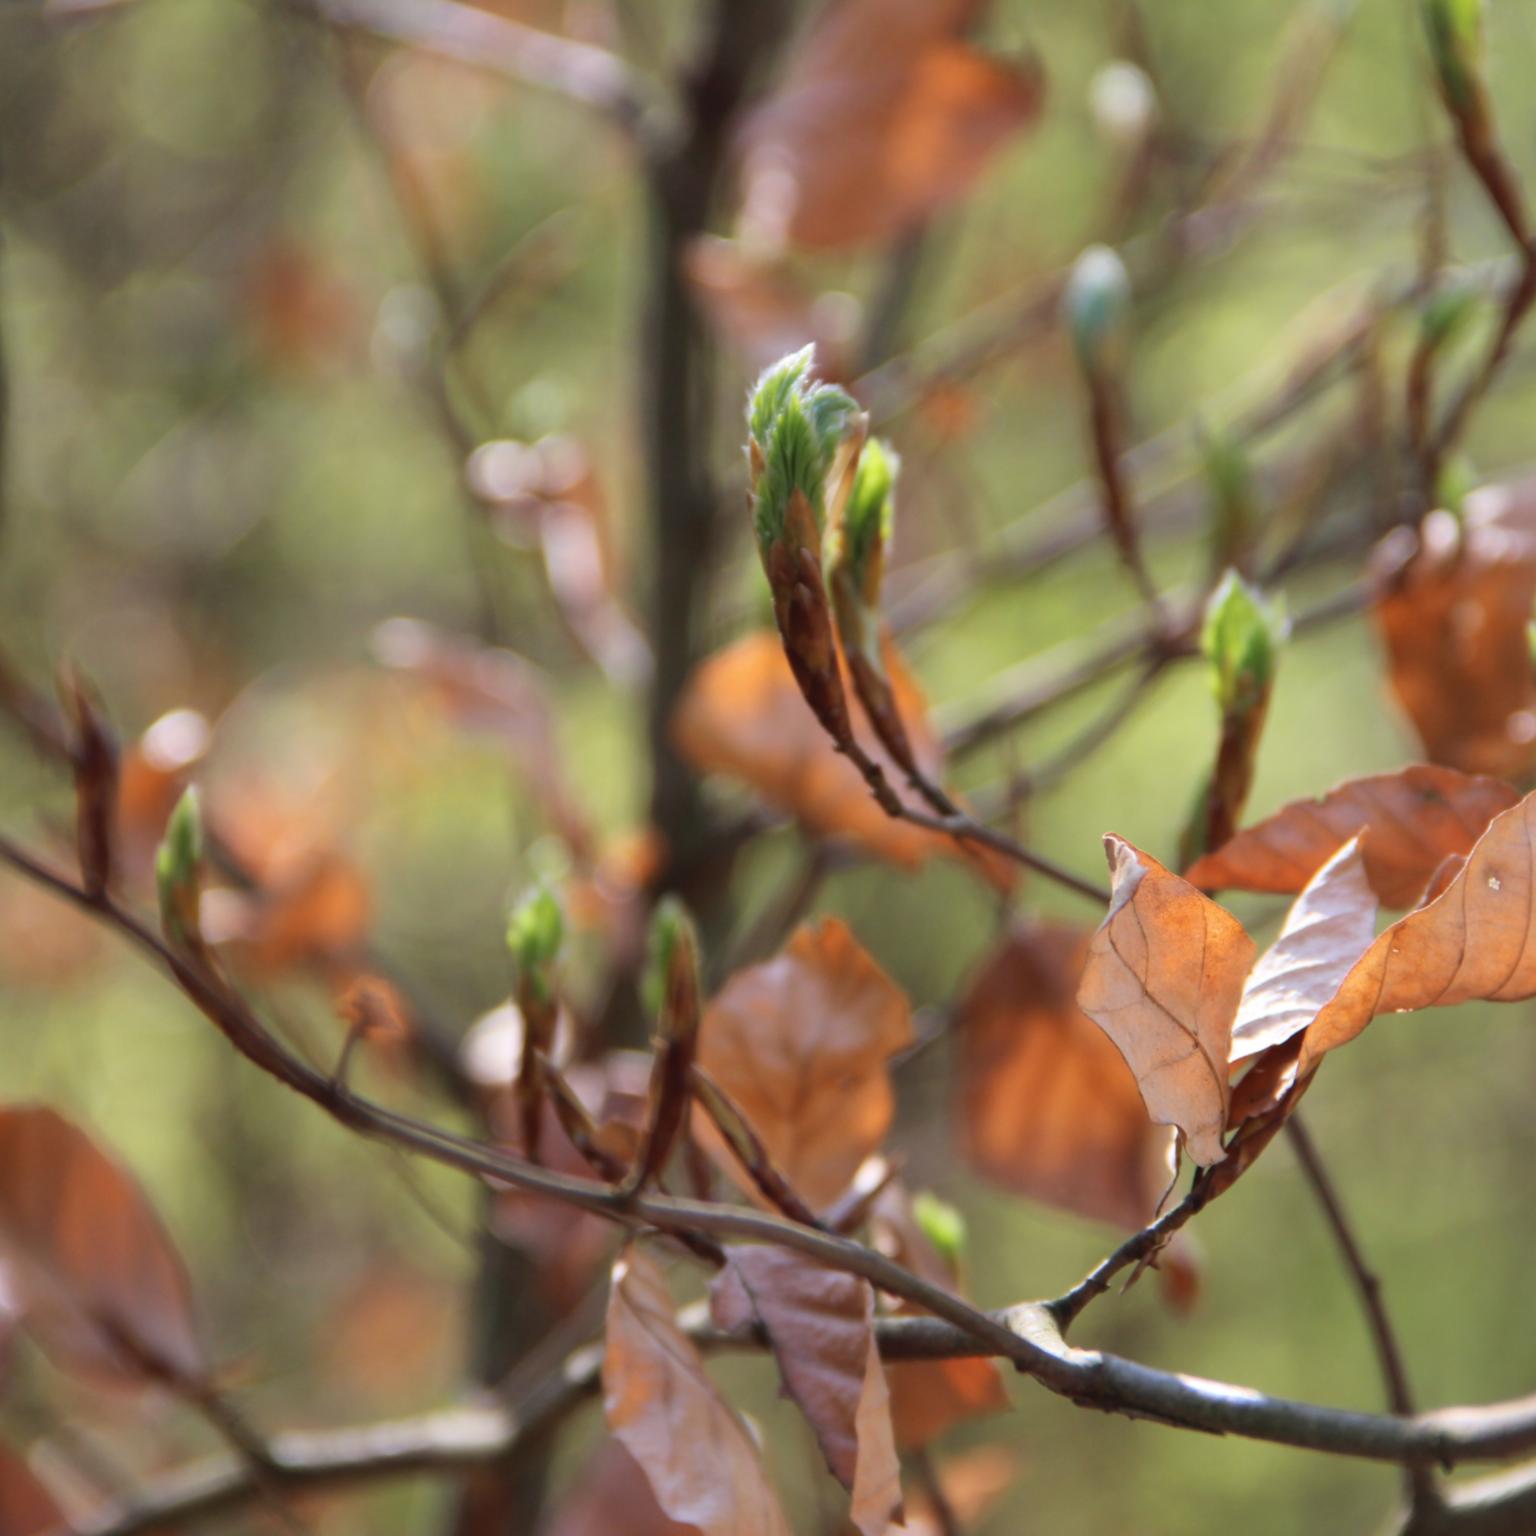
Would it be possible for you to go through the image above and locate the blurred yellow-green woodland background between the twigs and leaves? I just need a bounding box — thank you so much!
[0,0,1536,1536]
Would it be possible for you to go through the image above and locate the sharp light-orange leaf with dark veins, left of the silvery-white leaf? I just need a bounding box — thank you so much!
[1077,834,1253,1166]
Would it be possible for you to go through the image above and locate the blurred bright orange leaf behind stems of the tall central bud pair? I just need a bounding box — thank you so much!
[673,630,1015,891]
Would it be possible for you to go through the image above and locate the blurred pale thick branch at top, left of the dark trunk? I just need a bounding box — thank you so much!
[312,0,656,137]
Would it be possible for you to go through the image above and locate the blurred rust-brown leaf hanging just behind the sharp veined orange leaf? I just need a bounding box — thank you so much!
[954,925,1169,1227]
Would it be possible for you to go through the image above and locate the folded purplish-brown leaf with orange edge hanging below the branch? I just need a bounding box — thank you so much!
[710,1244,902,1536]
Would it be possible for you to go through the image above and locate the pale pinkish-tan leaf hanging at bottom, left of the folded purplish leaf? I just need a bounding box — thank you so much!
[602,1246,790,1536]
